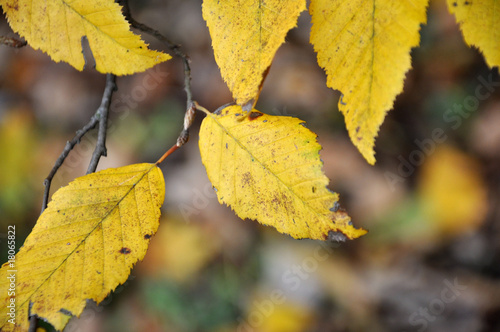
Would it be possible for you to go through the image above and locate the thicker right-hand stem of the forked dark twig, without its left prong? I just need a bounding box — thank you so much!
[87,74,116,174]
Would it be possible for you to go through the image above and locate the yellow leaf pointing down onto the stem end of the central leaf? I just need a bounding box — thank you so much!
[203,0,306,106]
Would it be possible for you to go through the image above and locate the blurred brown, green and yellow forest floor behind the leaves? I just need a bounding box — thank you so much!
[0,0,500,332]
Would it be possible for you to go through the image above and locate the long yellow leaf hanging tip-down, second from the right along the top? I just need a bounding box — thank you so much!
[309,0,428,165]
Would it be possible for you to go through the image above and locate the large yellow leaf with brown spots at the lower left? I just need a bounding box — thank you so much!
[0,164,165,331]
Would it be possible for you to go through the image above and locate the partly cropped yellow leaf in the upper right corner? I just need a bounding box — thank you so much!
[447,0,500,67]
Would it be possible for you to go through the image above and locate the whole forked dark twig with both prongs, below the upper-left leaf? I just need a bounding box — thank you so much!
[42,74,116,212]
